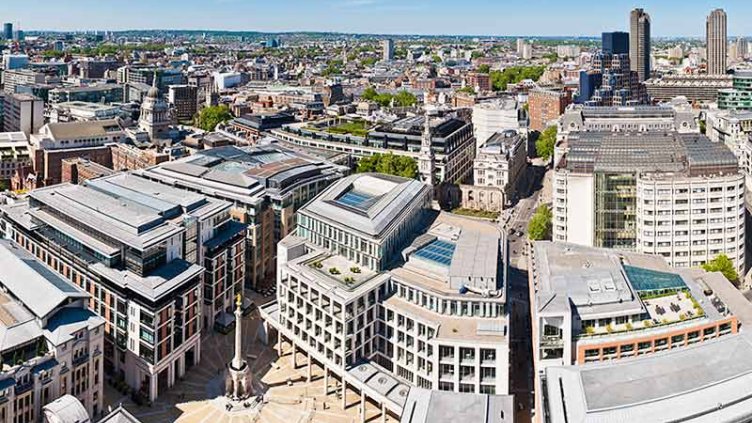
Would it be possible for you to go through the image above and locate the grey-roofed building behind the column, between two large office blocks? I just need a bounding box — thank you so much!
[135,145,349,287]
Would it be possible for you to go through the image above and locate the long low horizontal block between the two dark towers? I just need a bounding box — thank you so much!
[644,75,733,103]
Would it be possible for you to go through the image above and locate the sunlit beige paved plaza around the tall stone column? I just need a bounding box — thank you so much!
[105,311,398,423]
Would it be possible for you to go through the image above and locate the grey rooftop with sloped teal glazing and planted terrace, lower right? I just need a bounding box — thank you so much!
[533,242,736,337]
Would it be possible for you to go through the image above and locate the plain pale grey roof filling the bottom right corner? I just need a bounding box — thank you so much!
[545,333,752,423]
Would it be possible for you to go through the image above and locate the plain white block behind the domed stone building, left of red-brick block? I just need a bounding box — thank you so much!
[473,97,527,149]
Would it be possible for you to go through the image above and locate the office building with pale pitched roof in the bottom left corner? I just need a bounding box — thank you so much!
[0,240,105,423]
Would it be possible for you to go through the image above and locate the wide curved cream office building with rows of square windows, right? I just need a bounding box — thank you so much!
[553,131,746,274]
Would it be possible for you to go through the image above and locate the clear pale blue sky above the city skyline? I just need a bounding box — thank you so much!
[5,0,752,37]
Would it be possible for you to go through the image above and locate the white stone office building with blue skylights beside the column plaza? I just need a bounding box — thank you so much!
[261,174,509,418]
